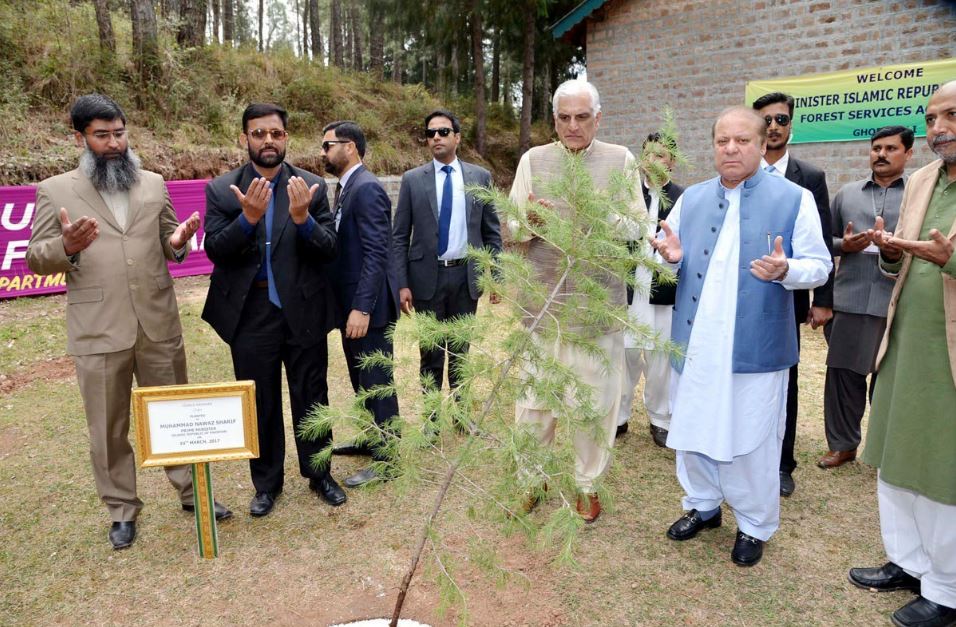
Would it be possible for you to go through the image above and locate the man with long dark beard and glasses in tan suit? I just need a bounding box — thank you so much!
[27,94,232,549]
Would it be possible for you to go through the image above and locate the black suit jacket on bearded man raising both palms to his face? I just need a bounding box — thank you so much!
[202,163,336,344]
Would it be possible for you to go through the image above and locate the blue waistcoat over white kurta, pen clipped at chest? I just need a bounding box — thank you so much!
[671,169,803,373]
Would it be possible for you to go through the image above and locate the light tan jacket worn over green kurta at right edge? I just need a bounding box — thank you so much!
[876,159,956,385]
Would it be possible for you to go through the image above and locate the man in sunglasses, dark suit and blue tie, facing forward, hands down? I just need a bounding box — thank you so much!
[393,110,501,408]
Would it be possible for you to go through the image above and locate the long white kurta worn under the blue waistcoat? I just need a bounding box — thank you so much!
[667,186,832,461]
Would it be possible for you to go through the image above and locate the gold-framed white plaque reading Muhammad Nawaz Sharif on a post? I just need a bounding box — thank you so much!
[133,381,259,468]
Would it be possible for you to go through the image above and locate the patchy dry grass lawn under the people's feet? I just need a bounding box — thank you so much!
[0,277,910,627]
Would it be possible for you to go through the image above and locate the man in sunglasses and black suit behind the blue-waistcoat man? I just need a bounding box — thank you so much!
[752,92,833,496]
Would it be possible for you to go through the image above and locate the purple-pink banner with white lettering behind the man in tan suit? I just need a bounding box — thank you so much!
[0,179,212,298]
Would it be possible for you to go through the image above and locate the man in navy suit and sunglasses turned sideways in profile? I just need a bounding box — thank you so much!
[322,121,398,488]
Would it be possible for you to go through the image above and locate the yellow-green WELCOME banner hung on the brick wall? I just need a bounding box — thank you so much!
[746,59,956,144]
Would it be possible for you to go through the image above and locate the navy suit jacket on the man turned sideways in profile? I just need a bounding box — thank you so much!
[329,165,399,328]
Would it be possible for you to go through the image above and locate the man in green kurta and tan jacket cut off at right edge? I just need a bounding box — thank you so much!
[849,81,956,627]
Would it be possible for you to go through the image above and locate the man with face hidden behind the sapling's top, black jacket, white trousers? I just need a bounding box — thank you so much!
[615,133,684,447]
